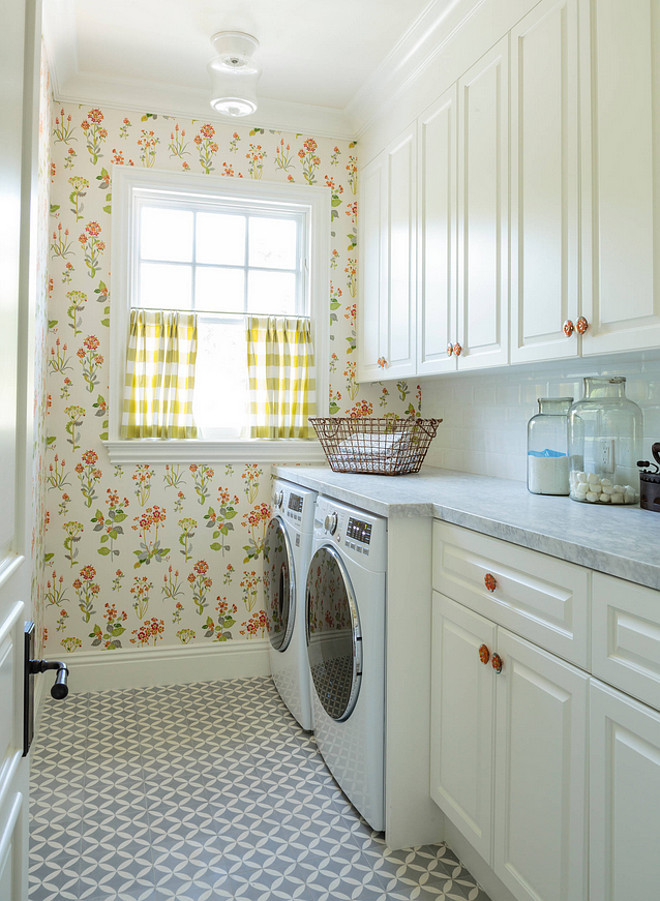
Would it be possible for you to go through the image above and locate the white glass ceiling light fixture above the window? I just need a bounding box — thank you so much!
[208,31,261,117]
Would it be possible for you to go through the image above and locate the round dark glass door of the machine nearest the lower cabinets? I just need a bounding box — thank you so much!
[306,545,362,721]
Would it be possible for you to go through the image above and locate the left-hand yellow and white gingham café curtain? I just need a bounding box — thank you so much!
[121,309,197,438]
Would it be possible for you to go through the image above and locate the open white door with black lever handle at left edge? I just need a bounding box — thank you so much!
[0,0,40,901]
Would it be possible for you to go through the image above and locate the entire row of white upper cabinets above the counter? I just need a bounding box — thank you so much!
[359,0,660,381]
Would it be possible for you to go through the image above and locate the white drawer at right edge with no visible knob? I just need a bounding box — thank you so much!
[591,573,660,710]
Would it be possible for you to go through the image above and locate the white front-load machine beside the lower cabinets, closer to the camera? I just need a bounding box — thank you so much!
[305,495,387,831]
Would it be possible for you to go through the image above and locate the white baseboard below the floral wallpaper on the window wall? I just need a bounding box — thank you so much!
[61,639,270,693]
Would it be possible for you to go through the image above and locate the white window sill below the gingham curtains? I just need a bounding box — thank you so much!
[103,438,326,465]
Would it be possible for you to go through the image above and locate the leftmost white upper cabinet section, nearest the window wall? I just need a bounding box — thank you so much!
[358,124,417,381]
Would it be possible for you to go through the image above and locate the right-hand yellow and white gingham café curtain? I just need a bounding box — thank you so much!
[247,316,316,438]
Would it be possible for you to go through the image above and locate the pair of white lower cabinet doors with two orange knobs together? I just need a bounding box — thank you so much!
[431,592,588,901]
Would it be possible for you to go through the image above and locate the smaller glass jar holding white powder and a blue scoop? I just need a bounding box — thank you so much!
[527,397,573,495]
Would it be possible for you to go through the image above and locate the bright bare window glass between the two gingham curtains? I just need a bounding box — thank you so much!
[193,317,248,437]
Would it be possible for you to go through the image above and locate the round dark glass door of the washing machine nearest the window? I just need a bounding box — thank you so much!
[264,516,296,651]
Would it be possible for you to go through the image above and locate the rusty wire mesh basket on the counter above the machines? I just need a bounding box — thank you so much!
[309,416,442,476]
